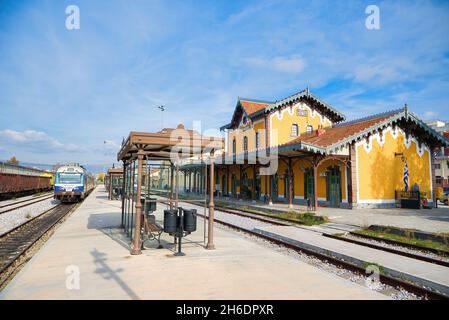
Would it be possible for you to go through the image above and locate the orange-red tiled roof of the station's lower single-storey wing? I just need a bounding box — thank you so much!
[285,110,401,148]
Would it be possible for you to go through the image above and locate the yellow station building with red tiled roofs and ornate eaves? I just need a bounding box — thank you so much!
[185,89,449,208]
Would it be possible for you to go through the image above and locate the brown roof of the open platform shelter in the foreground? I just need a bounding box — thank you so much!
[117,124,224,161]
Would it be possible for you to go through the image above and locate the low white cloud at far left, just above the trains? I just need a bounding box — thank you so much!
[0,129,85,153]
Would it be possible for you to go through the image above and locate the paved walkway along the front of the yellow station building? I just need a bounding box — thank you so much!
[212,198,449,232]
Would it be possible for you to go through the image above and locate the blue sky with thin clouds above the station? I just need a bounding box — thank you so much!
[0,0,449,169]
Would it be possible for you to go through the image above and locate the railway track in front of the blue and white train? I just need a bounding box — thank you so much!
[0,204,77,288]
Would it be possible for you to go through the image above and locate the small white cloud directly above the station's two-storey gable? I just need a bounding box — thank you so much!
[247,55,306,74]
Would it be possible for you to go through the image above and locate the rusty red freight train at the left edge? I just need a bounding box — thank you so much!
[0,161,54,200]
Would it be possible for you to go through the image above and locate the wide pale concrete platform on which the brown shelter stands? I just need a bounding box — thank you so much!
[0,187,387,299]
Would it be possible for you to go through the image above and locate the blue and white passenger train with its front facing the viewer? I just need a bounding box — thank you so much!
[54,164,95,202]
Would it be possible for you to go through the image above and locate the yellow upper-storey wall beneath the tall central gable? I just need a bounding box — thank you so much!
[270,102,332,146]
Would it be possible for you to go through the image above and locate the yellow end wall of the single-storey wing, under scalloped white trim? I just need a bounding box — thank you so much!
[356,127,431,203]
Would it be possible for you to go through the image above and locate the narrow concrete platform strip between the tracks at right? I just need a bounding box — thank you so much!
[254,226,449,296]
